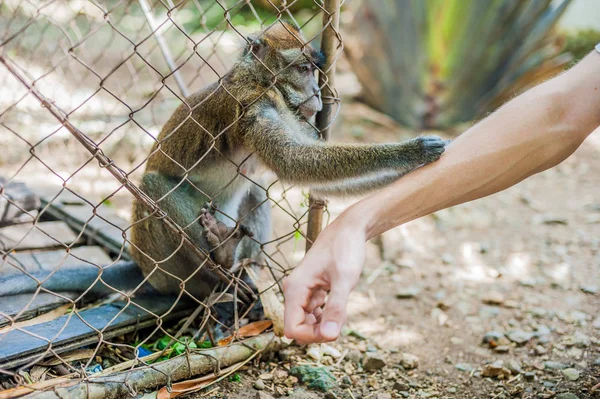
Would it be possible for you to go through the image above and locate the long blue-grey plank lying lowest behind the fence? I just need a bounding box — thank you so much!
[0,296,192,370]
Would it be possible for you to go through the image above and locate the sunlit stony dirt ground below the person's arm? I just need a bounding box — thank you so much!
[185,112,600,399]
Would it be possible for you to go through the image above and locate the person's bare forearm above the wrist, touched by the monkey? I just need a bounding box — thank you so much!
[340,49,600,238]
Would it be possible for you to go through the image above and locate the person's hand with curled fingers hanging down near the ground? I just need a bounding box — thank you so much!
[283,212,366,344]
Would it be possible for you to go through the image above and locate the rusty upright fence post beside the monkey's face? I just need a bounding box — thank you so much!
[306,0,341,251]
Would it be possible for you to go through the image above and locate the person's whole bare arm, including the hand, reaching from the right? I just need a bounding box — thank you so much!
[284,52,600,342]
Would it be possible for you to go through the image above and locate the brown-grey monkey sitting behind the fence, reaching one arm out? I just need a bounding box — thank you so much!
[131,23,445,300]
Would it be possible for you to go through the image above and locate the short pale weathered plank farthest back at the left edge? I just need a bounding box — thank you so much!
[0,221,77,251]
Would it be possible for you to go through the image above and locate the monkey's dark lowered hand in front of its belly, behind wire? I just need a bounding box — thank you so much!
[200,210,252,269]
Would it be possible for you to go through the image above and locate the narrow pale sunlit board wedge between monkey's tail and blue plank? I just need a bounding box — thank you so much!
[0,292,81,328]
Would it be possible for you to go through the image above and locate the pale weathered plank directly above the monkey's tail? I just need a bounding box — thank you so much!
[0,245,112,276]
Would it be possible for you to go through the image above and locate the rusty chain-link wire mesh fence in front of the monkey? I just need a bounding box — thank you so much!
[0,0,342,397]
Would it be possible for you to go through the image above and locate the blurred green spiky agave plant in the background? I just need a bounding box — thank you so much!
[345,0,571,128]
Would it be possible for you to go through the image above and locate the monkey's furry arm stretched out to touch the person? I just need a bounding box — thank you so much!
[245,110,446,186]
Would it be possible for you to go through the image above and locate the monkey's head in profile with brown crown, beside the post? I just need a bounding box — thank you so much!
[245,23,325,119]
